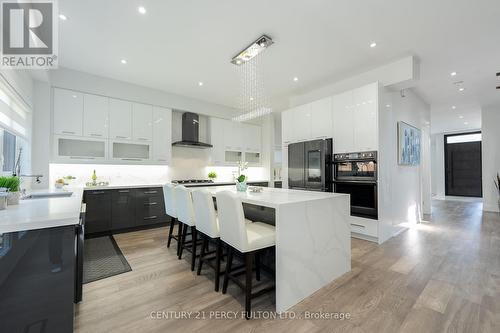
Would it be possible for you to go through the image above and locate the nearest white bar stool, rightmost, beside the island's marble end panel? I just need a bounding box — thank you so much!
[216,191,276,319]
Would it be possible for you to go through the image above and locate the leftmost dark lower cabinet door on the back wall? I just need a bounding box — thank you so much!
[84,190,112,234]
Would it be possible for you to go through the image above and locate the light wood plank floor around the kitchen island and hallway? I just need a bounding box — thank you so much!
[75,201,500,333]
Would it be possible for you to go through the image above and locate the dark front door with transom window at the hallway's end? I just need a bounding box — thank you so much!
[445,133,483,197]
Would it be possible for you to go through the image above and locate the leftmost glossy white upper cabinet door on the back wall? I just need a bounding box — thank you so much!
[54,88,83,136]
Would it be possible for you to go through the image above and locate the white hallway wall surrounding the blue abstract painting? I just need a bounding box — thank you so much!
[378,90,431,243]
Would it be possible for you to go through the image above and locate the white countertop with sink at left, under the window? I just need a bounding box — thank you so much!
[0,188,83,234]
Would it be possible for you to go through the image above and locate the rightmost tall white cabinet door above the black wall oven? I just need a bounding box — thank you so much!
[353,83,378,151]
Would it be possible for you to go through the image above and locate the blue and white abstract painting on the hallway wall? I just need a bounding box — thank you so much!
[398,121,421,165]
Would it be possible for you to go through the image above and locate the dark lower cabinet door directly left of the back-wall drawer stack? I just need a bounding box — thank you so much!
[111,189,135,230]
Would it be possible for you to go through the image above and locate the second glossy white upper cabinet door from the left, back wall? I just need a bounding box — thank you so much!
[83,94,109,138]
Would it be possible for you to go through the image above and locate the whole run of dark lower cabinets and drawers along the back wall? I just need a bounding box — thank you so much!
[84,187,170,235]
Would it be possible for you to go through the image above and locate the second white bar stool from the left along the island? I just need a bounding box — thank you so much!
[175,185,198,271]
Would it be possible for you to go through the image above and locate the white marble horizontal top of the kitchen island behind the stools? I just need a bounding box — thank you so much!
[188,186,349,208]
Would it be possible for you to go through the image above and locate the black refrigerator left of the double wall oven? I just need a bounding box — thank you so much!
[288,139,333,192]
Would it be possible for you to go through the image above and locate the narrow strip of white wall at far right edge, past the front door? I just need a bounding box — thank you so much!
[481,106,500,212]
